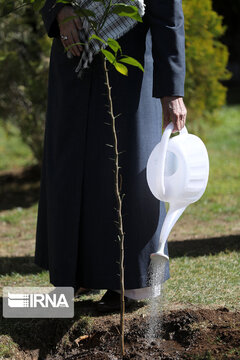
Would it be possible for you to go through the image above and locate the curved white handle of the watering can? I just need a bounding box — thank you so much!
[159,122,188,195]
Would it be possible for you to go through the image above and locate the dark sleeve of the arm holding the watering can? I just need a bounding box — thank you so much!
[145,0,185,98]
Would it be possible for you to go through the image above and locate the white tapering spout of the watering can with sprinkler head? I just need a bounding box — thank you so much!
[151,205,186,261]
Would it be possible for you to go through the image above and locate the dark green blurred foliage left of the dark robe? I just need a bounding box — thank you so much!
[0,0,51,163]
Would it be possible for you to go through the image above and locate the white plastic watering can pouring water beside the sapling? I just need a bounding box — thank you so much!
[146,122,209,261]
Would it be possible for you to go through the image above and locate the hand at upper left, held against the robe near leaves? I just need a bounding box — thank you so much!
[57,5,83,56]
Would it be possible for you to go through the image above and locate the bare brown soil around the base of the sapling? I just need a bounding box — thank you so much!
[47,307,240,360]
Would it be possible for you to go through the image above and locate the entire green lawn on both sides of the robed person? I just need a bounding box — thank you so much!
[0,106,240,359]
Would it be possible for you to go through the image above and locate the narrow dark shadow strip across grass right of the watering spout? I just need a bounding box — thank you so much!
[168,235,240,258]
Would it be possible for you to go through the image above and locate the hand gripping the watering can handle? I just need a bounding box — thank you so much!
[161,96,187,132]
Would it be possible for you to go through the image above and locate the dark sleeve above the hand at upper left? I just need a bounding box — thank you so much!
[40,0,70,37]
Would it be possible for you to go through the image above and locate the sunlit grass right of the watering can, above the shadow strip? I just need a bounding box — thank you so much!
[170,106,240,239]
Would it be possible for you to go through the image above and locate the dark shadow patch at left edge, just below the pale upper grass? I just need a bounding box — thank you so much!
[0,165,41,211]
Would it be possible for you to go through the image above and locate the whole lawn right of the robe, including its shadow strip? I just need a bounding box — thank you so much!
[165,102,240,309]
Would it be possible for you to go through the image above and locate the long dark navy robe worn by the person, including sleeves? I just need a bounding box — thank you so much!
[35,0,185,289]
